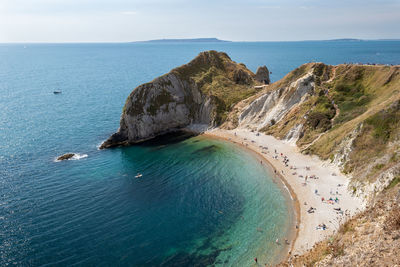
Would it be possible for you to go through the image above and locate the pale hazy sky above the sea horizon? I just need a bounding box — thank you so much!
[0,0,400,43]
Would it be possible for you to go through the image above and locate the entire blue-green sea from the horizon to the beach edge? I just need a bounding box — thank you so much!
[0,41,400,266]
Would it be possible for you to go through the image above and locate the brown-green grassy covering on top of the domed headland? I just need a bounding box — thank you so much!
[123,51,258,124]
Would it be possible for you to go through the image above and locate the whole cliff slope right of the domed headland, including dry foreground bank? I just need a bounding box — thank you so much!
[222,63,400,266]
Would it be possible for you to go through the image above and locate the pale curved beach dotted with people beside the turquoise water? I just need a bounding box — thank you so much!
[205,129,363,255]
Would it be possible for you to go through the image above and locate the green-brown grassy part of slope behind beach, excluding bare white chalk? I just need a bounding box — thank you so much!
[239,63,400,188]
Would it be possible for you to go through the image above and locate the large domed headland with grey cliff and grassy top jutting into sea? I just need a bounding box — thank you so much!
[100,51,266,149]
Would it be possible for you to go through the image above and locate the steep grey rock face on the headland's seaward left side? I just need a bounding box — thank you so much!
[101,73,215,148]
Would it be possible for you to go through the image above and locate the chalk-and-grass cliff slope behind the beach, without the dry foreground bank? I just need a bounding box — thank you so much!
[227,63,400,200]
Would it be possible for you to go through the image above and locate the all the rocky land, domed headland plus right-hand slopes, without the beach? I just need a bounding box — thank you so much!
[101,51,400,266]
